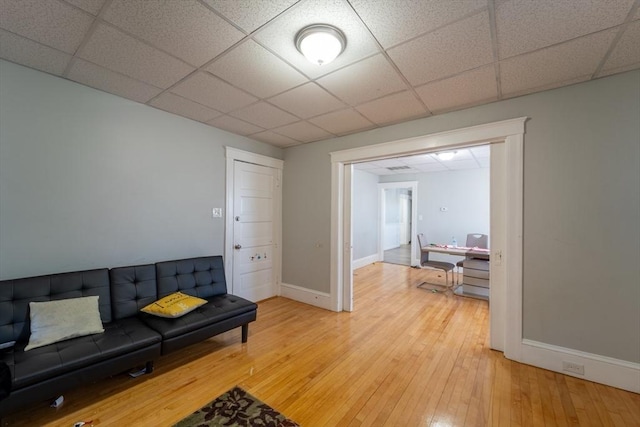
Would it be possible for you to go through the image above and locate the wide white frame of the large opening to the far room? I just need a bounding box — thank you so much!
[330,117,527,360]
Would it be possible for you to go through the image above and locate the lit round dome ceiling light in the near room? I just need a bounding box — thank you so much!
[295,24,347,65]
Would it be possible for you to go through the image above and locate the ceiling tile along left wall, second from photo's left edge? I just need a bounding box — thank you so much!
[67,59,162,102]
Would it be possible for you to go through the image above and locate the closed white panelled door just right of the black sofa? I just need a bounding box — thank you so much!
[233,161,278,301]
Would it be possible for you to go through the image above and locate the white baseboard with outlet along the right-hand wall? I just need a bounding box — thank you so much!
[521,339,640,393]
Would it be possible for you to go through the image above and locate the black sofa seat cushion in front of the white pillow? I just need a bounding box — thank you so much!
[4,317,161,389]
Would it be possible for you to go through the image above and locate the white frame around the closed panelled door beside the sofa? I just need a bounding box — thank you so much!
[224,147,284,295]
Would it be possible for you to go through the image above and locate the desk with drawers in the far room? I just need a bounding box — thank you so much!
[422,245,490,299]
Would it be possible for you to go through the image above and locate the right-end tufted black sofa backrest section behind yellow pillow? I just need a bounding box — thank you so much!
[156,255,227,298]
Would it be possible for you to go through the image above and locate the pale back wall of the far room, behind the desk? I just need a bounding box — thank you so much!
[380,168,490,264]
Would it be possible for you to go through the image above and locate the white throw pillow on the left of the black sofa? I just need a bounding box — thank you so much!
[24,296,104,351]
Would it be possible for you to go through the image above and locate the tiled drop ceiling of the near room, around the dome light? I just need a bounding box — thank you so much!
[0,0,640,147]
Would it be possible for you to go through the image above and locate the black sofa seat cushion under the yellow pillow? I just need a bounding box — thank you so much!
[141,294,257,339]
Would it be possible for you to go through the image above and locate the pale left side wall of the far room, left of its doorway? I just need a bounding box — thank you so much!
[351,169,379,260]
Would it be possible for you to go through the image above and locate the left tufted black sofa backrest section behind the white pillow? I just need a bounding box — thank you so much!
[0,268,111,343]
